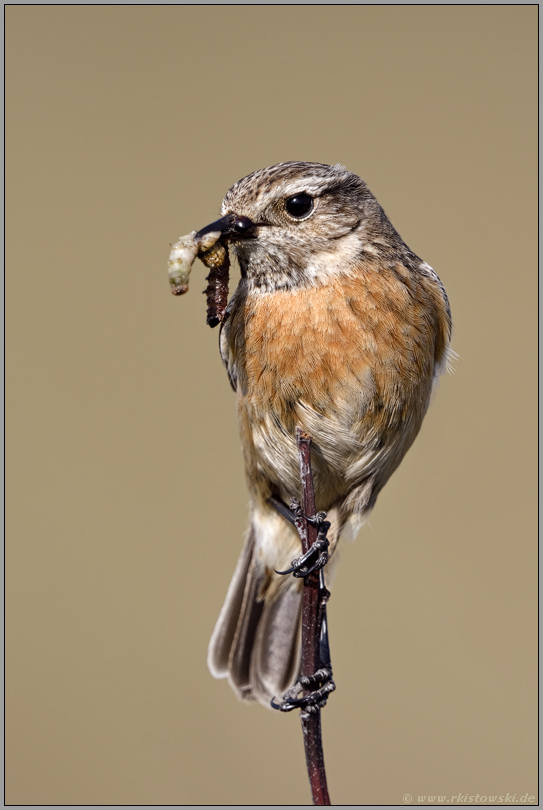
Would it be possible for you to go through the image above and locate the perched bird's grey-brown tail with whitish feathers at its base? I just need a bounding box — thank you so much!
[207,506,302,708]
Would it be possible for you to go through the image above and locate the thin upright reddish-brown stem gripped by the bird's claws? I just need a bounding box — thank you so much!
[296,428,331,805]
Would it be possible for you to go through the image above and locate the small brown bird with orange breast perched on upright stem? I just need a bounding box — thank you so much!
[199,161,452,707]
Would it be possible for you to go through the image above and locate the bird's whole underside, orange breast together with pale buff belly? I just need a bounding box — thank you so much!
[221,263,450,508]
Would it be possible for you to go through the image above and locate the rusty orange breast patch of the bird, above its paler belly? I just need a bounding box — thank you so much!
[236,272,439,410]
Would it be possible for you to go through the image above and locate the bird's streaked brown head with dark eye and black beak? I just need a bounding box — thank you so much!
[194,161,395,292]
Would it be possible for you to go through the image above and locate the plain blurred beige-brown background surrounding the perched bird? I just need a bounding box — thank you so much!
[6,5,537,804]
